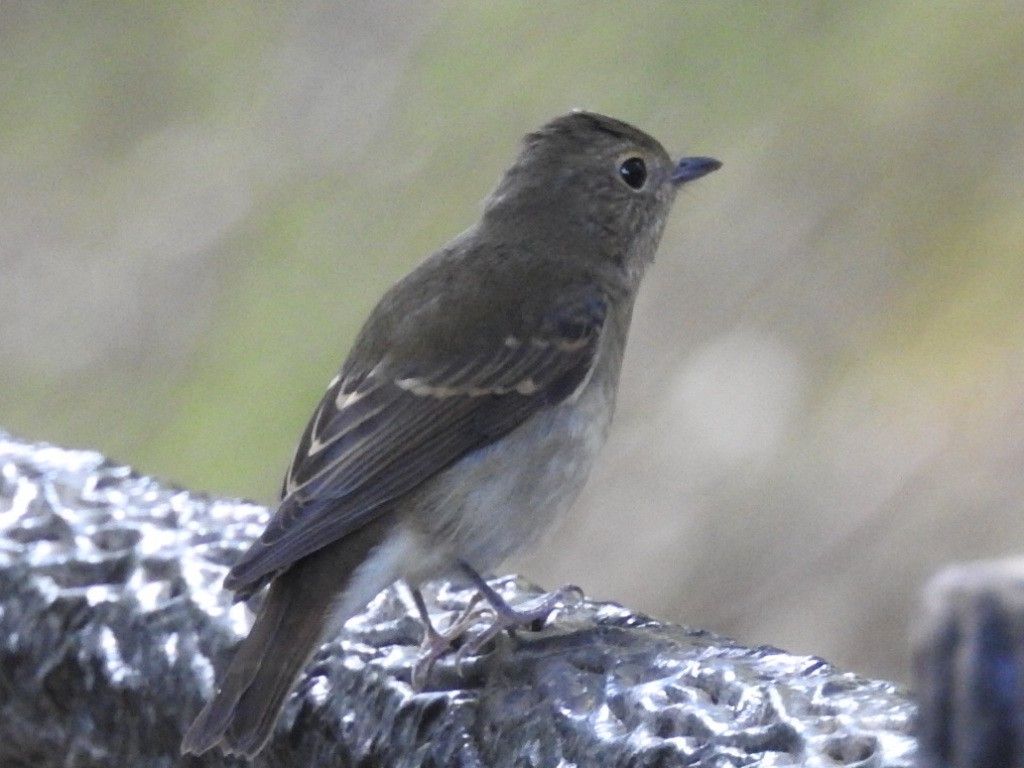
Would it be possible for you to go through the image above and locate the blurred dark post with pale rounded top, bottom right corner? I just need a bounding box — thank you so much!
[914,558,1024,768]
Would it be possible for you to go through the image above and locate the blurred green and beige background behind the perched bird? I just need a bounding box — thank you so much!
[0,0,1024,679]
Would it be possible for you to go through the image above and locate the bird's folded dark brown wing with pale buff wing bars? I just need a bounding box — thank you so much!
[224,292,607,599]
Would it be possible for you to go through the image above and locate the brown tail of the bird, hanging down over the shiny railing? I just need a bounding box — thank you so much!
[181,524,395,757]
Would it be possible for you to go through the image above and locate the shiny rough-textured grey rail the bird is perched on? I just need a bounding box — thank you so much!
[0,433,915,768]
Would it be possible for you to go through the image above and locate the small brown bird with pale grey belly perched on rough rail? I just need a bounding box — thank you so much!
[181,110,722,757]
